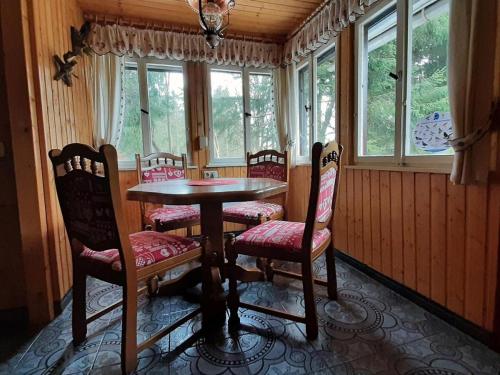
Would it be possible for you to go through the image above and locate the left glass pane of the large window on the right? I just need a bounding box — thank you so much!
[358,8,397,156]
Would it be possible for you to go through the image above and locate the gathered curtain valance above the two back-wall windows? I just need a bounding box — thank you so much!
[89,23,282,68]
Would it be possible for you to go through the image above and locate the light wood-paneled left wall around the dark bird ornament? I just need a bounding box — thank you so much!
[30,0,93,301]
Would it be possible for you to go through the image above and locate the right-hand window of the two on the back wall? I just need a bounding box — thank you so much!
[209,67,279,164]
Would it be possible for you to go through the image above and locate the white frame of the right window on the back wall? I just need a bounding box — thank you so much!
[207,65,276,167]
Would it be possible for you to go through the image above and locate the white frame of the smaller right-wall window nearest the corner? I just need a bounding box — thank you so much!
[294,37,339,164]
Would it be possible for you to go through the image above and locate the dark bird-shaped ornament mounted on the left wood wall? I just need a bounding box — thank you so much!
[54,22,92,87]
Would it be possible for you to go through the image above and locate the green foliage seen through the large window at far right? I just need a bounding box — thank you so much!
[362,13,449,155]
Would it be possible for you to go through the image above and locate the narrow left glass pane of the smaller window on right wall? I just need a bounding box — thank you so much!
[298,65,312,157]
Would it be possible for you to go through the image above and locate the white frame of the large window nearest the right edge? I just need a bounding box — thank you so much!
[354,0,453,168]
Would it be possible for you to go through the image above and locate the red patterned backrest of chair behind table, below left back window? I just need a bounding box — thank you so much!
[135,152,187,184]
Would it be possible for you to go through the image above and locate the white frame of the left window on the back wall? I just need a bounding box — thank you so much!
[118,57,191,170]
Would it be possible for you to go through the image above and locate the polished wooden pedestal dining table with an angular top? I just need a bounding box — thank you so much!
[127,178,288,329]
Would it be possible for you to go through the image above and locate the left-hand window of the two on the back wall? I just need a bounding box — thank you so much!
[117,59,188,167]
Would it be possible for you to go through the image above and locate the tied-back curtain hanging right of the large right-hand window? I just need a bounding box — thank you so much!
[448,0,498,184]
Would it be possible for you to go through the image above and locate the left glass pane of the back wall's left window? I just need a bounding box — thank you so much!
[116,65,143,160]
